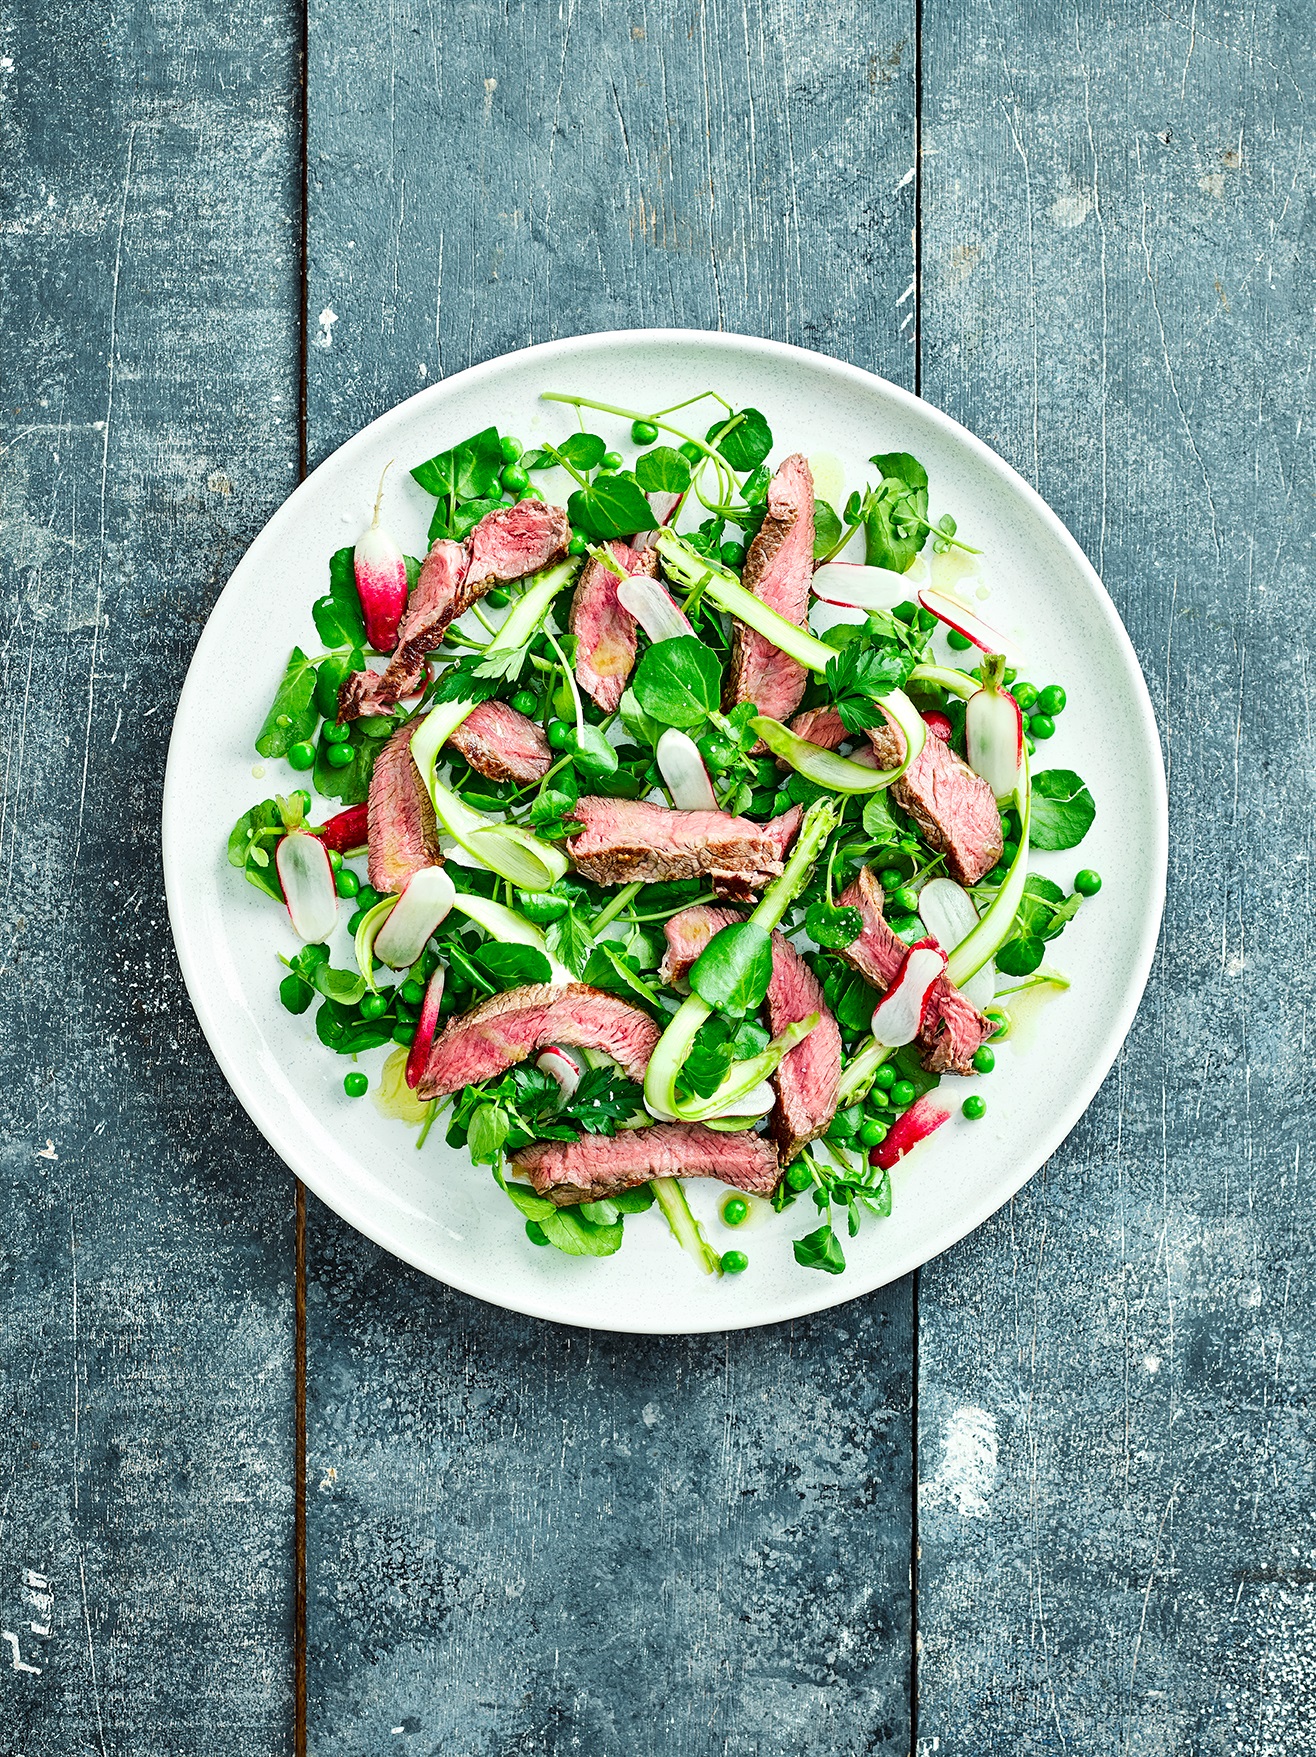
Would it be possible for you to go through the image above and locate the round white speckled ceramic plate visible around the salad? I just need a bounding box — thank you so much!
[163,330,1167,1334]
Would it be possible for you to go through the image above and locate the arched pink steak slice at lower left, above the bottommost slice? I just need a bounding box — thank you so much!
[416,982,662,1098]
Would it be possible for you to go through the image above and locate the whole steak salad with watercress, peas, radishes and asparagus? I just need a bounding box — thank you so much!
[228,392,1100,1274]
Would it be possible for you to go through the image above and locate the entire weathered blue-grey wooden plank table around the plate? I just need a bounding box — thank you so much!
[0,0,1316,1757]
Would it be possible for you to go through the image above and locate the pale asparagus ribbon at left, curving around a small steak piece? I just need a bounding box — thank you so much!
[411,557,580,891]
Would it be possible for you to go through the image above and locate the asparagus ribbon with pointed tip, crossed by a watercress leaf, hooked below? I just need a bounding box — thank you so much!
[645,799,842,1123]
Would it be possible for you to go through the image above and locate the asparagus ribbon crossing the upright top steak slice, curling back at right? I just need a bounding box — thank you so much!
[657,531,920,792]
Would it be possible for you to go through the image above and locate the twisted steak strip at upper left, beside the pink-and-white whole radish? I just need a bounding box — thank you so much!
[337,501,571,722]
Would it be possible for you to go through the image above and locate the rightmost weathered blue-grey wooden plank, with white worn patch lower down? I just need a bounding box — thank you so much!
[917,0,1316,1757]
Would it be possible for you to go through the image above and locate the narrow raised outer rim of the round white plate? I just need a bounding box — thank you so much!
[162,327,1168,1335]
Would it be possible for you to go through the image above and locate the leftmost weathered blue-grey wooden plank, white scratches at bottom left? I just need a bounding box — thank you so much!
[0,0,299,1757]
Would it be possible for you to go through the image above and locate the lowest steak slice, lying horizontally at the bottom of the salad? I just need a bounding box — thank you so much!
[511,1123,780,1207]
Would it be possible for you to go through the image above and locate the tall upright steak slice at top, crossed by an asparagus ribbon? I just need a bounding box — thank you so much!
[726,452,813,737]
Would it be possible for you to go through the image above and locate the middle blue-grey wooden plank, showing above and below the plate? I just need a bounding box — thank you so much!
[307,0,914,1757]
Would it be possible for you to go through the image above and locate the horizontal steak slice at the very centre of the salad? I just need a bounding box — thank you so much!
[568,794,782,891]
